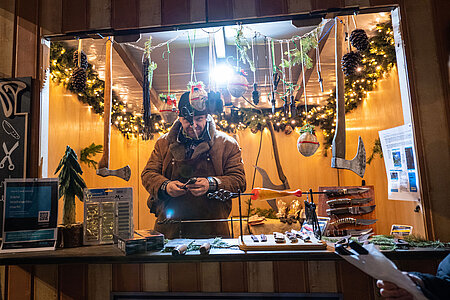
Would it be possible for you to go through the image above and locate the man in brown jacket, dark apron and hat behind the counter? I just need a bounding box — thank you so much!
[141,92,246,238]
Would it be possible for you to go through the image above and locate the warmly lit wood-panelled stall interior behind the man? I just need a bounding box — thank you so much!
[42,13,425,236]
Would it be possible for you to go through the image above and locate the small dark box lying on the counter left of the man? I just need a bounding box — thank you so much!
[114,230,164,255]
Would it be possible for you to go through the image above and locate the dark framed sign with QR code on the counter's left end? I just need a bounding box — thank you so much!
[1,178,58,252]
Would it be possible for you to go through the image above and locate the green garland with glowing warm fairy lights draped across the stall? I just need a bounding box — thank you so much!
[50,21,396,149]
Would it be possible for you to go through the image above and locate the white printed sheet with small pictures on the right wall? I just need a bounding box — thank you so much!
[379,124,420,201]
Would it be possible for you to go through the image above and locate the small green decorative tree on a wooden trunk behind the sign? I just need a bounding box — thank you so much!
[55,146,86,225]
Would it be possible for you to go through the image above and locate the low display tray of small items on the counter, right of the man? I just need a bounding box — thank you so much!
[238,234,327,251]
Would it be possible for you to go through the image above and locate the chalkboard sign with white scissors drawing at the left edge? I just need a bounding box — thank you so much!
[0,77,31,182]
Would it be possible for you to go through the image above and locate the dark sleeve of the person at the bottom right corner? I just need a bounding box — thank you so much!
[412,255,450,300]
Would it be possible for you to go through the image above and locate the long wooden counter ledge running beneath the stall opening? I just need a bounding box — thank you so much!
[0,239,450,265]
